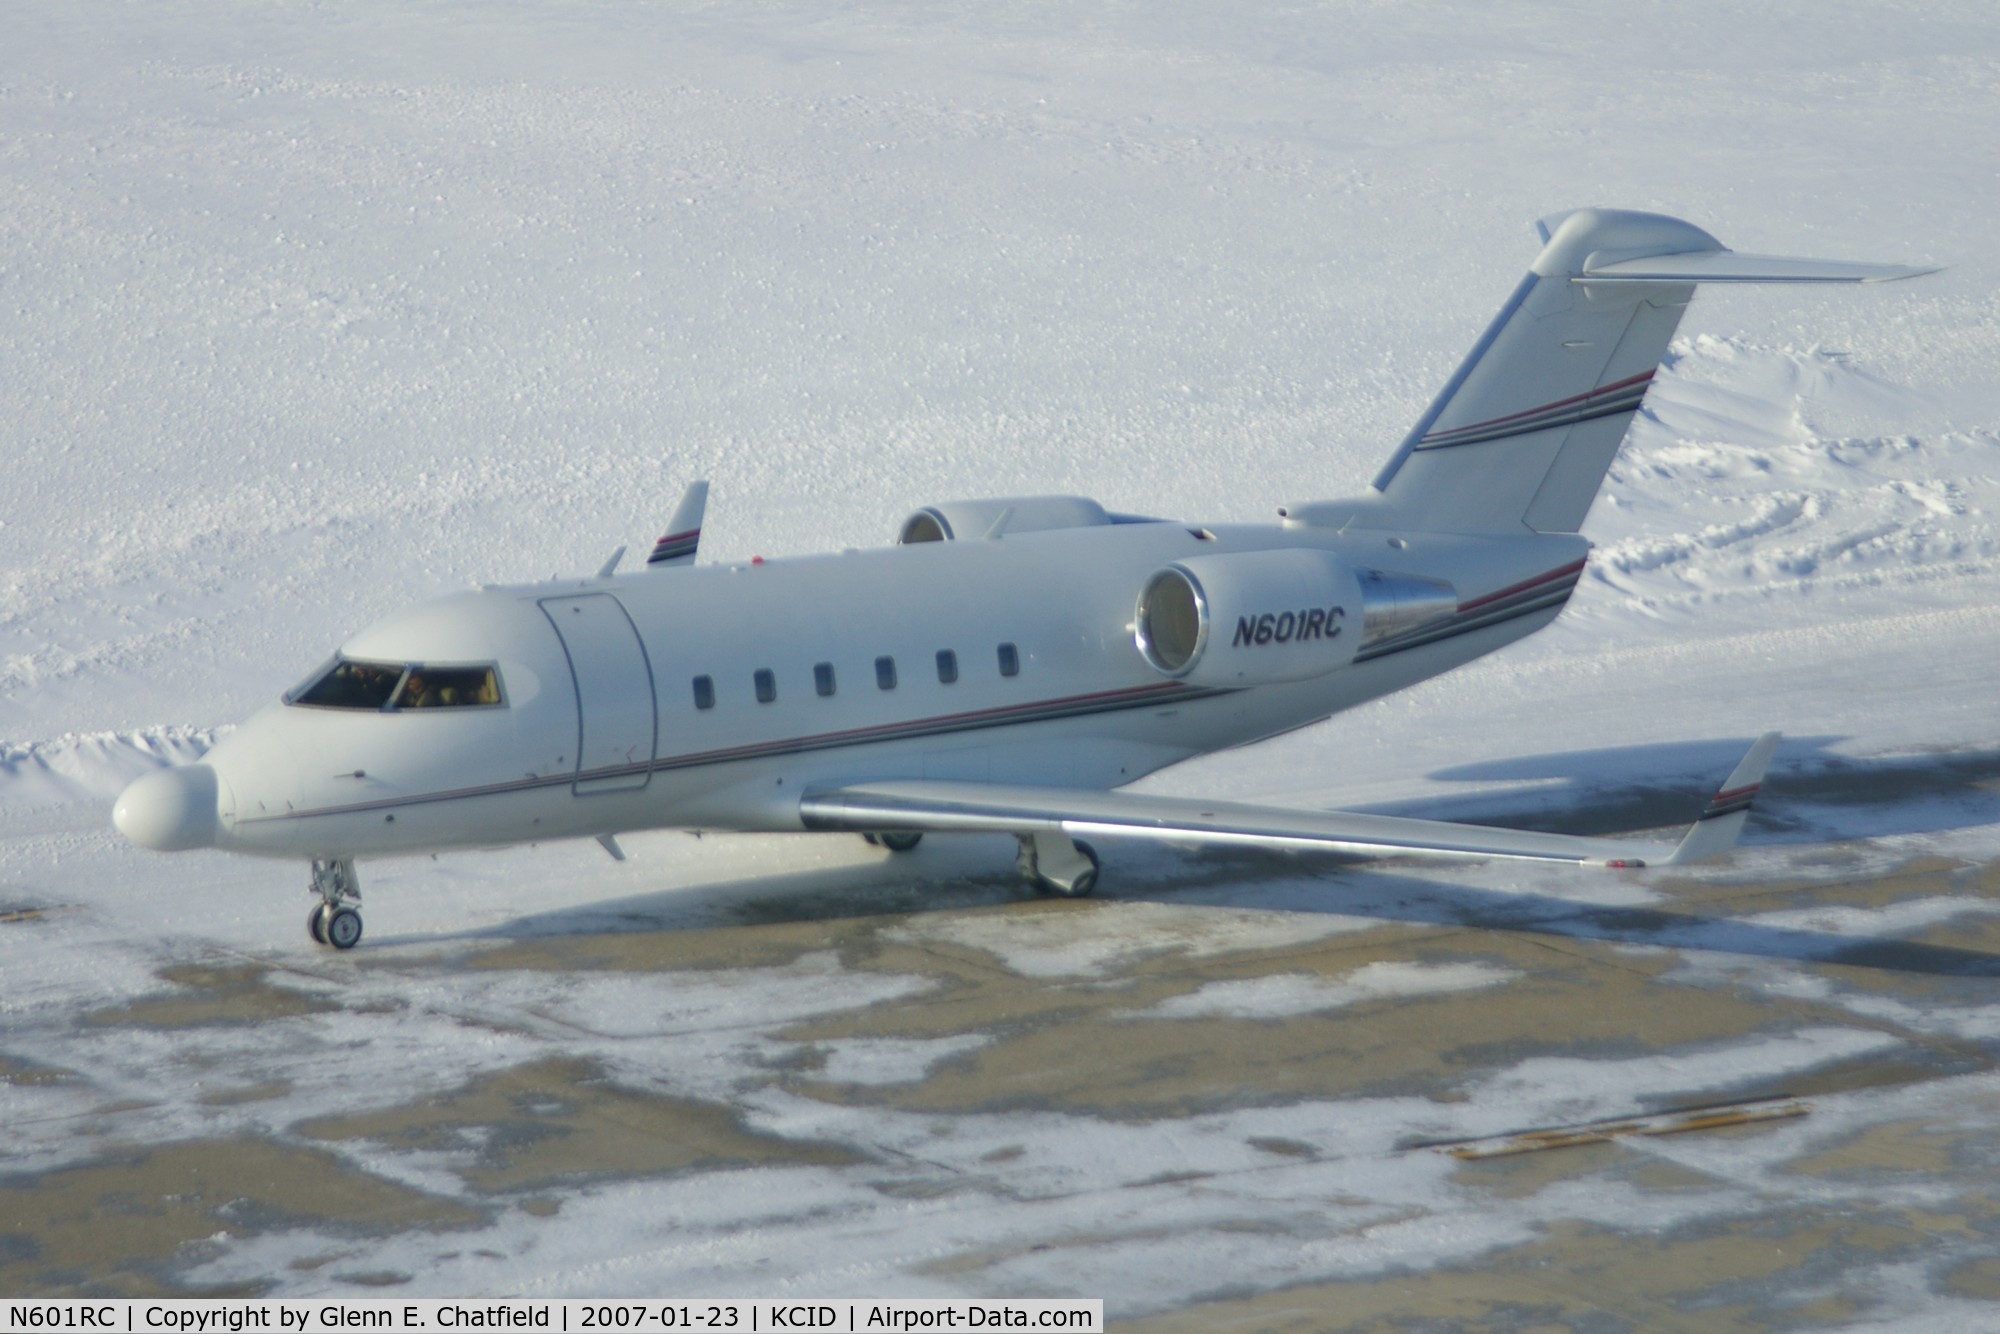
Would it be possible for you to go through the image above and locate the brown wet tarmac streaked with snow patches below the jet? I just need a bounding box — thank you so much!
[0,808,2000,1330]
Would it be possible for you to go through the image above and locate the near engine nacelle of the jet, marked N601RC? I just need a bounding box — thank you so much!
[1134,550,1362,686]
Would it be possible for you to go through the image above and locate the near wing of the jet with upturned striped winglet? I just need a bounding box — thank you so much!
[800,732,1778,868]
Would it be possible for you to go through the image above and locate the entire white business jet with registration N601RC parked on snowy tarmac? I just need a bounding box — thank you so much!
[112,210,1928,950]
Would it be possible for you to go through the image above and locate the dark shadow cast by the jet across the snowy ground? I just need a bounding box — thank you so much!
[402,736,2000,976]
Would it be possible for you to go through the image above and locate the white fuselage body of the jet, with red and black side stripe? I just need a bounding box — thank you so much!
[176,522,1588,858]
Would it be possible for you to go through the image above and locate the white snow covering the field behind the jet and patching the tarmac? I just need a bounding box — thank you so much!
[0,0,2000,1328]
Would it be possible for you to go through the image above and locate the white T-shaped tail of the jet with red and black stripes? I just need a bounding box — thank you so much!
[1286,208,1932,534]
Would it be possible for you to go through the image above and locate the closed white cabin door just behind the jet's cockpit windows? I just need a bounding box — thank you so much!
[542,592,658,796]
